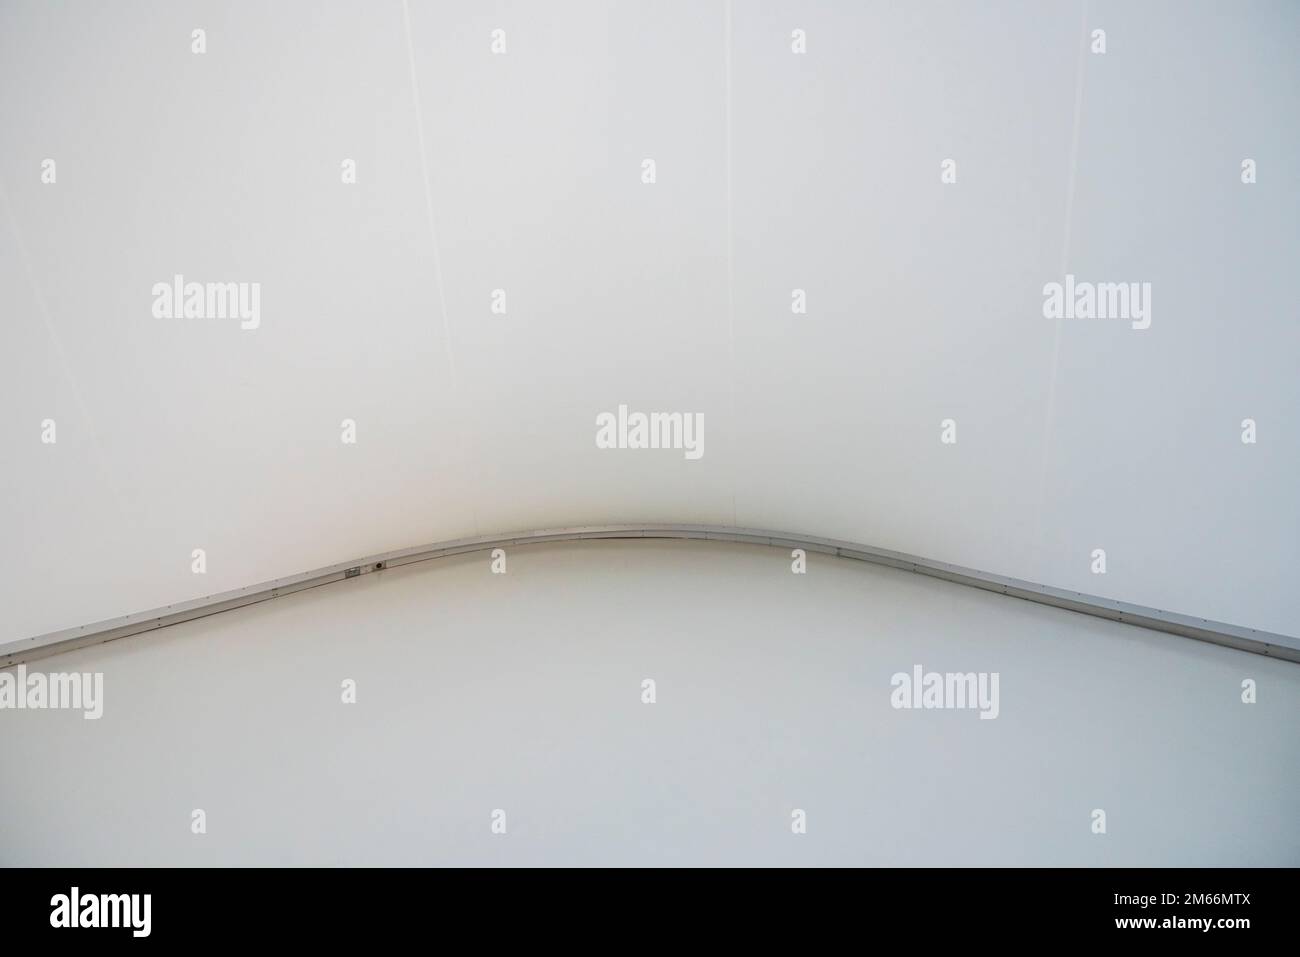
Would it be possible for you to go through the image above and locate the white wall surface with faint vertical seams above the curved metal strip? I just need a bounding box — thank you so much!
[0,0,1300,640]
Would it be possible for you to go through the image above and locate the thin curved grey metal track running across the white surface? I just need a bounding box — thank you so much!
[0,525,1300,667]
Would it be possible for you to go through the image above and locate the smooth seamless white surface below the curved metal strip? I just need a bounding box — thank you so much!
[0,541,1300,866]
